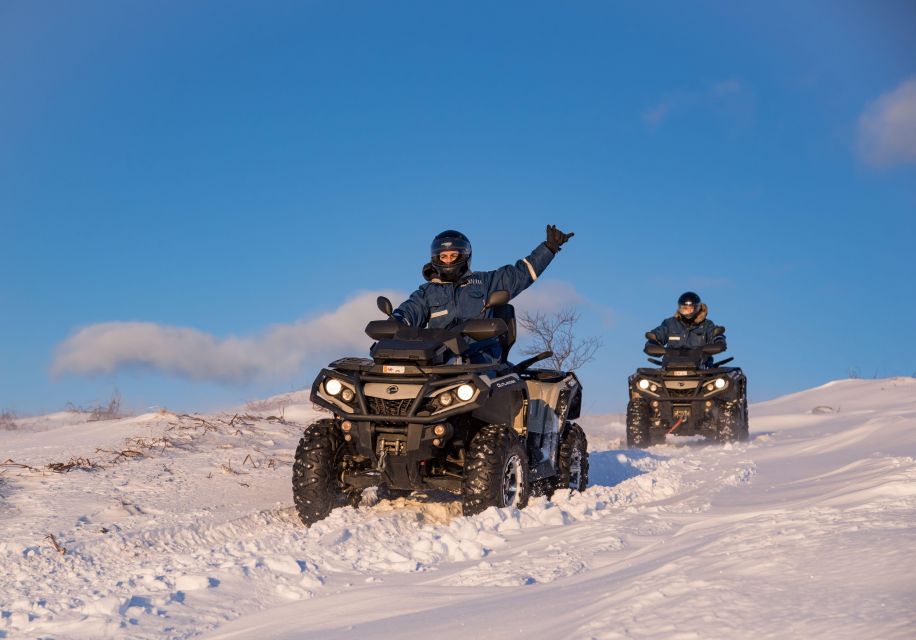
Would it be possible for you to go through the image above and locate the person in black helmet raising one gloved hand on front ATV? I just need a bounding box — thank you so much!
[392,225,574,362]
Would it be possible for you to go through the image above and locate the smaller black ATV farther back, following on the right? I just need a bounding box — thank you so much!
[627,327,748,447]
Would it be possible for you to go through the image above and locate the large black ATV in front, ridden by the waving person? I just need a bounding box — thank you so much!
[293,291,588,526]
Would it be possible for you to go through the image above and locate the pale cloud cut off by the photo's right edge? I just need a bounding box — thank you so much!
[859,77,916,167]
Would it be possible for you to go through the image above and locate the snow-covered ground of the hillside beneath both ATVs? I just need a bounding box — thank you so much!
[0,378,916,640]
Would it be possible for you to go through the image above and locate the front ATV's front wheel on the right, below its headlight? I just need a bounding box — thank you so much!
[461,424,530,516]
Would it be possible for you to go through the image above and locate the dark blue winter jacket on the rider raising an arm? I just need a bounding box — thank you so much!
[392,242,553,329]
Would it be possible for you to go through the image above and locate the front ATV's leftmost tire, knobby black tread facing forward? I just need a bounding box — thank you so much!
[293,420,347,527]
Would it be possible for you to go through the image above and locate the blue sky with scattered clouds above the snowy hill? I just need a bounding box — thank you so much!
[0,0,916,414]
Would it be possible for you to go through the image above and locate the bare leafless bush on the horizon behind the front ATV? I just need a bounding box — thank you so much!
[518,309,603,371]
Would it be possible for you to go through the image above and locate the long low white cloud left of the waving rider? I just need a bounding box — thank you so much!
[52,291,405,383]
